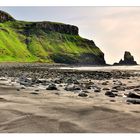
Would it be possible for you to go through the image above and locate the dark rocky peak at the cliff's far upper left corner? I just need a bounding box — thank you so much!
[0,11,15,22]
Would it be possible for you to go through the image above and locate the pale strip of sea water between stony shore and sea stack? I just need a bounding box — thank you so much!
[60,65,140,71]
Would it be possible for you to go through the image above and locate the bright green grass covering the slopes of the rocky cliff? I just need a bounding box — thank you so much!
[0,21,101,63]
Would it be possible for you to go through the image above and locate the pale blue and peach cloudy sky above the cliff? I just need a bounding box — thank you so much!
[0,6,140,64]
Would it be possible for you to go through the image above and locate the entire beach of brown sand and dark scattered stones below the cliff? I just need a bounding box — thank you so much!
[0,63,140,133]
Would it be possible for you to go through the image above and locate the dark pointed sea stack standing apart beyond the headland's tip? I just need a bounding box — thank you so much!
[114,51,137,65]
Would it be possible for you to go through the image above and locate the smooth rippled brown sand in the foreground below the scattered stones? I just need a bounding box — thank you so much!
[0,79,140,133]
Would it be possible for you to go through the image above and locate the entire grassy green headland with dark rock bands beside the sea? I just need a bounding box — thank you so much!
[0,11,106,65]
